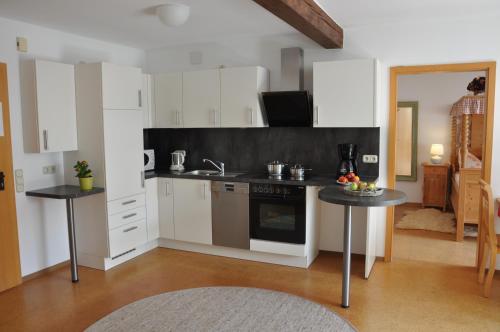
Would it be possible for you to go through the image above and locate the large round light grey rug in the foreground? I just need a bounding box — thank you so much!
[87,287,355,331]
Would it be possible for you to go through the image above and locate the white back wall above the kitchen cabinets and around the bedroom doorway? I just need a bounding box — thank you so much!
[146,13,500,256]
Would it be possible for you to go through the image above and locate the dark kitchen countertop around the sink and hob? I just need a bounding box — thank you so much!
[145,170,377,187]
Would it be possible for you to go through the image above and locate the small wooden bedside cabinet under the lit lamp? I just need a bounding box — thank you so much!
[422,163,450,211]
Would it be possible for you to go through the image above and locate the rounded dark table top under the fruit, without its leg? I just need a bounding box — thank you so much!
[318,185,408,207]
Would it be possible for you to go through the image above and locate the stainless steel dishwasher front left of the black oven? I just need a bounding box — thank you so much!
[212,181,250,249]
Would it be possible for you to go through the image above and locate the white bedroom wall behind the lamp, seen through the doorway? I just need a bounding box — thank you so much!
[396,72,485,203]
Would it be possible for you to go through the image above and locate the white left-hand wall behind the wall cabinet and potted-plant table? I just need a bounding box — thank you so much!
[0,18,145,275]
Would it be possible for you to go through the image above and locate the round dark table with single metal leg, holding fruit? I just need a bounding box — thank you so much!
[318,185,407,308]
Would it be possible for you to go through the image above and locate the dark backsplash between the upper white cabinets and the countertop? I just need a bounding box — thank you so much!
[144,128,380,176]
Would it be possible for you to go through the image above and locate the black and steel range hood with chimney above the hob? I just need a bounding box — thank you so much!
[262,47,312,127]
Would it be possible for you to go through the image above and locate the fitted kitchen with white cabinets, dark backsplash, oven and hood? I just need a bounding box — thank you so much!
[29,48,380,278]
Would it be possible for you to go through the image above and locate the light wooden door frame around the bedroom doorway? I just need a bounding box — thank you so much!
[384,61,496,262]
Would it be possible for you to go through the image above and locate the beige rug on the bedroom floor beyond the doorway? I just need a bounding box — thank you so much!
[396,209,477,237]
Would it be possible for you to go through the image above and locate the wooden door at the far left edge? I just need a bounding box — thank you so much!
[0,63,21,292]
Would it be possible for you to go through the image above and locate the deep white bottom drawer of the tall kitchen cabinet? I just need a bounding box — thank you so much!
[109,220,148,257]
